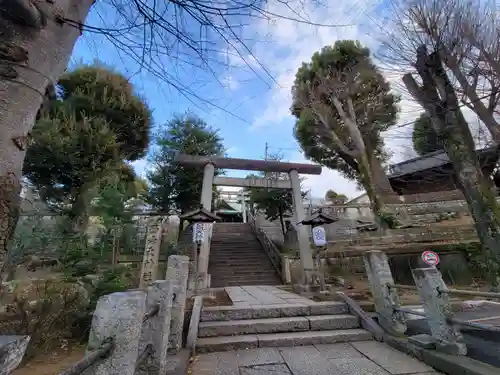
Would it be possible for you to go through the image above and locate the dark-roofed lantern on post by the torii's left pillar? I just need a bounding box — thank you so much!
[180,206,221,293]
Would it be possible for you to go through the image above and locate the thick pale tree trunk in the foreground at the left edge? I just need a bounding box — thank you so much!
[0,0,93,273]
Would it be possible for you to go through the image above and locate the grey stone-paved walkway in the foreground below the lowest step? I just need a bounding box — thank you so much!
[191,341,441,375]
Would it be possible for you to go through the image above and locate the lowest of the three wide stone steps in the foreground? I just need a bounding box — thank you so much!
[196,329,373,353]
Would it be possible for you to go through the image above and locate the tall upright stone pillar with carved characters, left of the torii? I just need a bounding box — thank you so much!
[139,217,164,289]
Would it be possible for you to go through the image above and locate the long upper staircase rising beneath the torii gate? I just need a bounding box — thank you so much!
[208,223,281,288]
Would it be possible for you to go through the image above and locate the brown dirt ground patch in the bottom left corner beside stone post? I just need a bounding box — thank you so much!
[12,345,85,375]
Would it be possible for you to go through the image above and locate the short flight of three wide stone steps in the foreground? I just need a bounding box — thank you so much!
[196,301,373,352]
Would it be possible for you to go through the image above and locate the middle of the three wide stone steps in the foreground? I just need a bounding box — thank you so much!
[198,315,359,337]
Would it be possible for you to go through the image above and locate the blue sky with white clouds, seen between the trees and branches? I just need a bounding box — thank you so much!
[71,0,426,203]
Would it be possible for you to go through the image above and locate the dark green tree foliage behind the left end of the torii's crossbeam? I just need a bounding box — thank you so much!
[148,114,225,213]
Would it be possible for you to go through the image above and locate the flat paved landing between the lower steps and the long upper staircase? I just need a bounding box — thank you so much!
[224,285,315,307]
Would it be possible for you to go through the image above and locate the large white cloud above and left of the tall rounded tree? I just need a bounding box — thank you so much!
[247,0,386,129]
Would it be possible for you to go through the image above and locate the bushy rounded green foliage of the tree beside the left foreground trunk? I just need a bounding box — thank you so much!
[23,66,152,222]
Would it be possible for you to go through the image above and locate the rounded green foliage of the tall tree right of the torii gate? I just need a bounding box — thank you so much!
[291,40,398,188]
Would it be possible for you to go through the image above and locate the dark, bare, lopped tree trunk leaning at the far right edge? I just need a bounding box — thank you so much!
[403,47,500,285]
